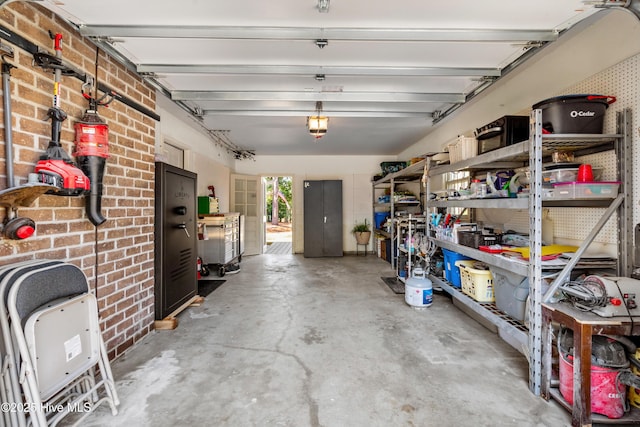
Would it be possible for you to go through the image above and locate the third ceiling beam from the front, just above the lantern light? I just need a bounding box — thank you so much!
[171,90,465,103]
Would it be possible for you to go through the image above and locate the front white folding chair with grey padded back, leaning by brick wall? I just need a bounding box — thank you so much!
[7,263,119,426]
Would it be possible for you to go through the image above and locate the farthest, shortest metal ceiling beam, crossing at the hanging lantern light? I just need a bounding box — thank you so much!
[201,109,433,120]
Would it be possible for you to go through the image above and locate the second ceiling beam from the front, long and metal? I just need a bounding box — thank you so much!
[136,64,500,77]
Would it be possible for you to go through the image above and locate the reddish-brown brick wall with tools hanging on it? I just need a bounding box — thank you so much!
[0,2,156,358]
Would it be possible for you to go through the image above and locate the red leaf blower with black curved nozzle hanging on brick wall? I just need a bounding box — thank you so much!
[73,110,109,226]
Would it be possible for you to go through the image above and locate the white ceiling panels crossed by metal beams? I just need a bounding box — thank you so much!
[39,0,596,155]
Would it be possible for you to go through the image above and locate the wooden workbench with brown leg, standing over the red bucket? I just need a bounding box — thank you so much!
[541,302,640,427]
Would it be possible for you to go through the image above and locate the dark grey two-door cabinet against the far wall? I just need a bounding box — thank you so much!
[304,180,343,258]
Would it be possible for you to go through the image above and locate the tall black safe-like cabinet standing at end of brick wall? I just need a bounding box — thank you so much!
[154,162,198,320]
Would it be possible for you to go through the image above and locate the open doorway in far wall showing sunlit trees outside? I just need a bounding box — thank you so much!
[264,176,293,255]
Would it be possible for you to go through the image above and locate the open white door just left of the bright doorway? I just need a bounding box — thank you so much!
[229,174,264,255]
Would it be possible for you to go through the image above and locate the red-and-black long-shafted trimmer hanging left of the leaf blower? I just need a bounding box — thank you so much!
[34,33,90,196]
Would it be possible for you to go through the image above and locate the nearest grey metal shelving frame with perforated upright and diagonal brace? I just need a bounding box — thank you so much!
[425,109,633,395]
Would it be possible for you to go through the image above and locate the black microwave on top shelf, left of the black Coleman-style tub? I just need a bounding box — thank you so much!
[474,116,529,154]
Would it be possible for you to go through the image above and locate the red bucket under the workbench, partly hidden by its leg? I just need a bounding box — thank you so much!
[559,352,626,418]
